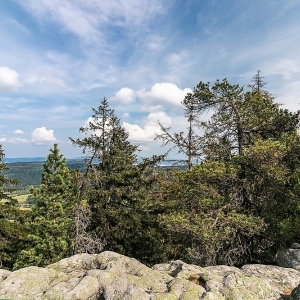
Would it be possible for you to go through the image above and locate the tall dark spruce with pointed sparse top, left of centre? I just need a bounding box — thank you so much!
[70,98,161,260]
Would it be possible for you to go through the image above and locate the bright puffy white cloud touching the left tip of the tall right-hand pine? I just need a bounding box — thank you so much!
[137,82,192,106]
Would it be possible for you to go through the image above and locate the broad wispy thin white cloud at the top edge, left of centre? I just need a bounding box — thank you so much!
[18,0,165,43]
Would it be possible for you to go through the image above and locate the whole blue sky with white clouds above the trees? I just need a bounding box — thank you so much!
[0,0,300,158]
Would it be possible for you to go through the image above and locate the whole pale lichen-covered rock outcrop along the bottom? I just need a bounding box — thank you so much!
[0,251,300,300]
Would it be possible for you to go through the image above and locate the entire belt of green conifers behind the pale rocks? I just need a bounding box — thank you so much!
[0,71,300,268]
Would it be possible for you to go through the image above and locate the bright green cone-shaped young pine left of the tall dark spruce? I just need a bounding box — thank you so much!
[15,144,78,268]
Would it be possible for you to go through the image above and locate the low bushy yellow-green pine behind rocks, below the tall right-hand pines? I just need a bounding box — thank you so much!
[155,161,266,265]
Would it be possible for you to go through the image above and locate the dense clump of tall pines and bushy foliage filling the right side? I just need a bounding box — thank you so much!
[159,73,300,264]
